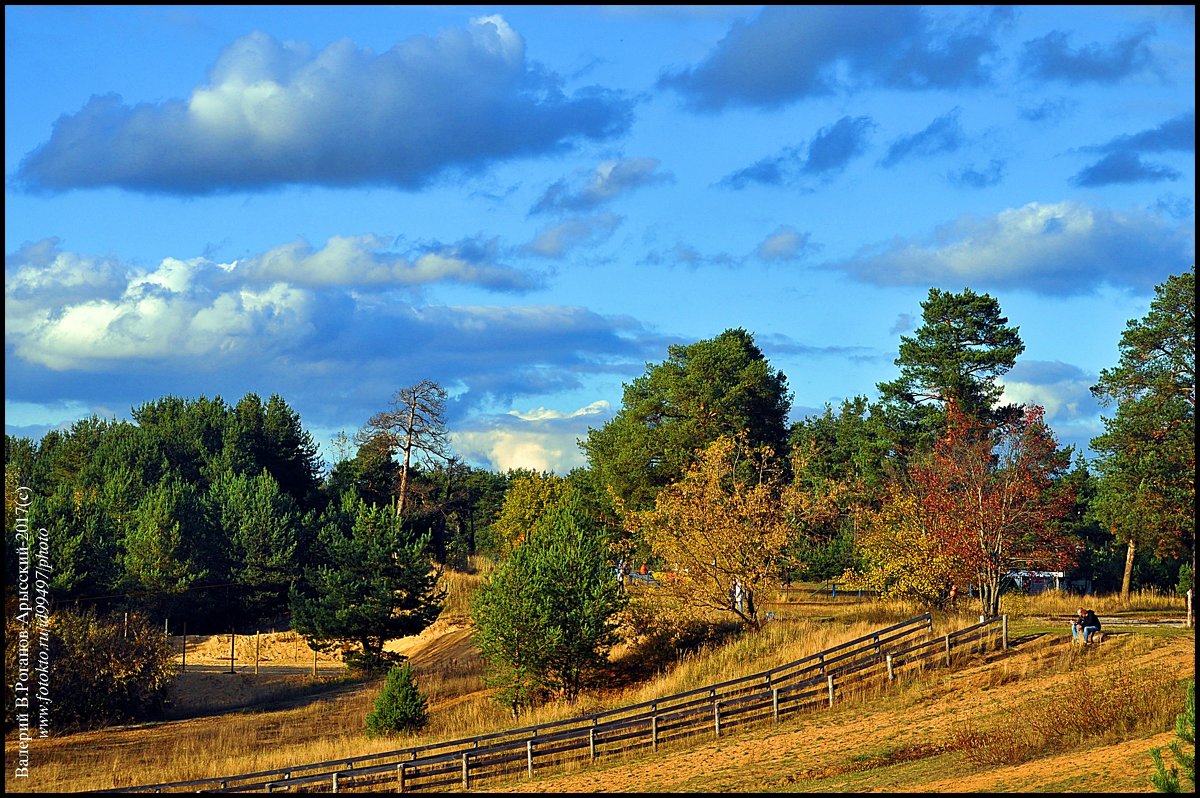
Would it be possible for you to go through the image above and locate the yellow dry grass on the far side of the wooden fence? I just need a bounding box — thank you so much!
[6,563,1183,792]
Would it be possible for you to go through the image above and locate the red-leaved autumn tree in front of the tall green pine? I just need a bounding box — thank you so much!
[911,402,1076,618]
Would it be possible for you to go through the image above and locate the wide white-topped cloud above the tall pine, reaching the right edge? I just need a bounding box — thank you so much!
[826,203,1195,296]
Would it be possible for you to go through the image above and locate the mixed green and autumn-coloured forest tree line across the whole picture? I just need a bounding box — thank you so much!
[5,268,1195,633]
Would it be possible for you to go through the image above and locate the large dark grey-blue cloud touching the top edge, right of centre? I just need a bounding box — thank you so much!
[659,6,1013,112]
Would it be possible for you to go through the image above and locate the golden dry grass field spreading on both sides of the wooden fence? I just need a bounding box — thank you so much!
[5,566,1195,793]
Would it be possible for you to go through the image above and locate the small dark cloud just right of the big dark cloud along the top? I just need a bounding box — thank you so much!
[1020,30,1153,84]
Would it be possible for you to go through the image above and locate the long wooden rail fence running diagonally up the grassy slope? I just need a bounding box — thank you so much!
[103,613,1008,792]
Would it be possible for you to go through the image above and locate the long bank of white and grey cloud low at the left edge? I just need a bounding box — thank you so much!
[5,236,630,379]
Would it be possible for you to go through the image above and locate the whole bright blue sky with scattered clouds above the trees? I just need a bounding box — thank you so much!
[5,5,1195,473]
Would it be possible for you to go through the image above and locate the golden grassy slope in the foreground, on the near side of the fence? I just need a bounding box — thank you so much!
[490,635,1195,793]
